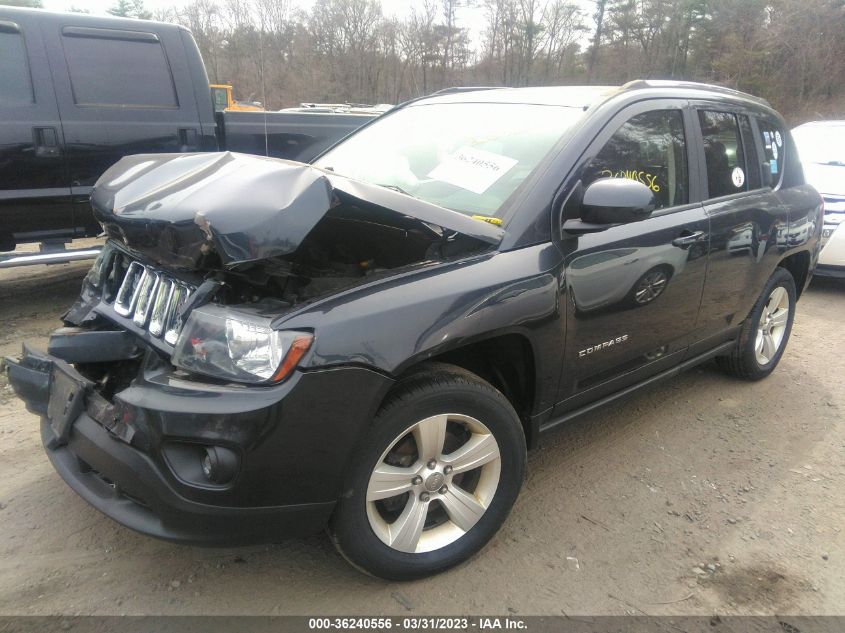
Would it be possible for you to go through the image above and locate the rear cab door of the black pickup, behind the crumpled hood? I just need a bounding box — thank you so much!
[43,21,201,237]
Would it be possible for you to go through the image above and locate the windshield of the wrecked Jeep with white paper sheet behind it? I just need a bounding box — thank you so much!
[315,103,584,217]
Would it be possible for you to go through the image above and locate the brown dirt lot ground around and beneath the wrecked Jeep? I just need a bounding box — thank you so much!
[0,254,845,615]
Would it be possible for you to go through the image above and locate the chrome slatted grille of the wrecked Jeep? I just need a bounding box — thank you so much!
[106,260,195,345]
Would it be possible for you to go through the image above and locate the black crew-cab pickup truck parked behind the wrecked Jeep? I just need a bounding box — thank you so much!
[0,7,375,251]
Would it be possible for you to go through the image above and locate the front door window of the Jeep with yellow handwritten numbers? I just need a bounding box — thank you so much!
[582,110,689,208]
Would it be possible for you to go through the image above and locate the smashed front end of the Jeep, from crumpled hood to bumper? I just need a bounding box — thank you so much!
[6,154,502,543]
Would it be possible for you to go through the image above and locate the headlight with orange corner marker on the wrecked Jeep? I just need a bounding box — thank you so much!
[172,305,313,383]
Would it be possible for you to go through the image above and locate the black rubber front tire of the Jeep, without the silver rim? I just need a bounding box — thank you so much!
[330,372,526,580]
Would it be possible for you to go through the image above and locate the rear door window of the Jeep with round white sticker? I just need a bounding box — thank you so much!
[698,110,748,198]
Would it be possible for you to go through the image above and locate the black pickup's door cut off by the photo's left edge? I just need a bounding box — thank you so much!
[0,14,74,250]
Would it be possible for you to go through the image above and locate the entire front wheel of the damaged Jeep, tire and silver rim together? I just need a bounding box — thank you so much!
[329,364,526,580]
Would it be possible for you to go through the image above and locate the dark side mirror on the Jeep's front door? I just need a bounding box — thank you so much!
[581,178,657,224]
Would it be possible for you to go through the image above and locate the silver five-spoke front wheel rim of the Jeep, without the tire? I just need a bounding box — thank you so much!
[367,413,502,553]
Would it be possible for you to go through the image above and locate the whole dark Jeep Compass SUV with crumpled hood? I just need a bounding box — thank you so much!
[6,81,823,579]
